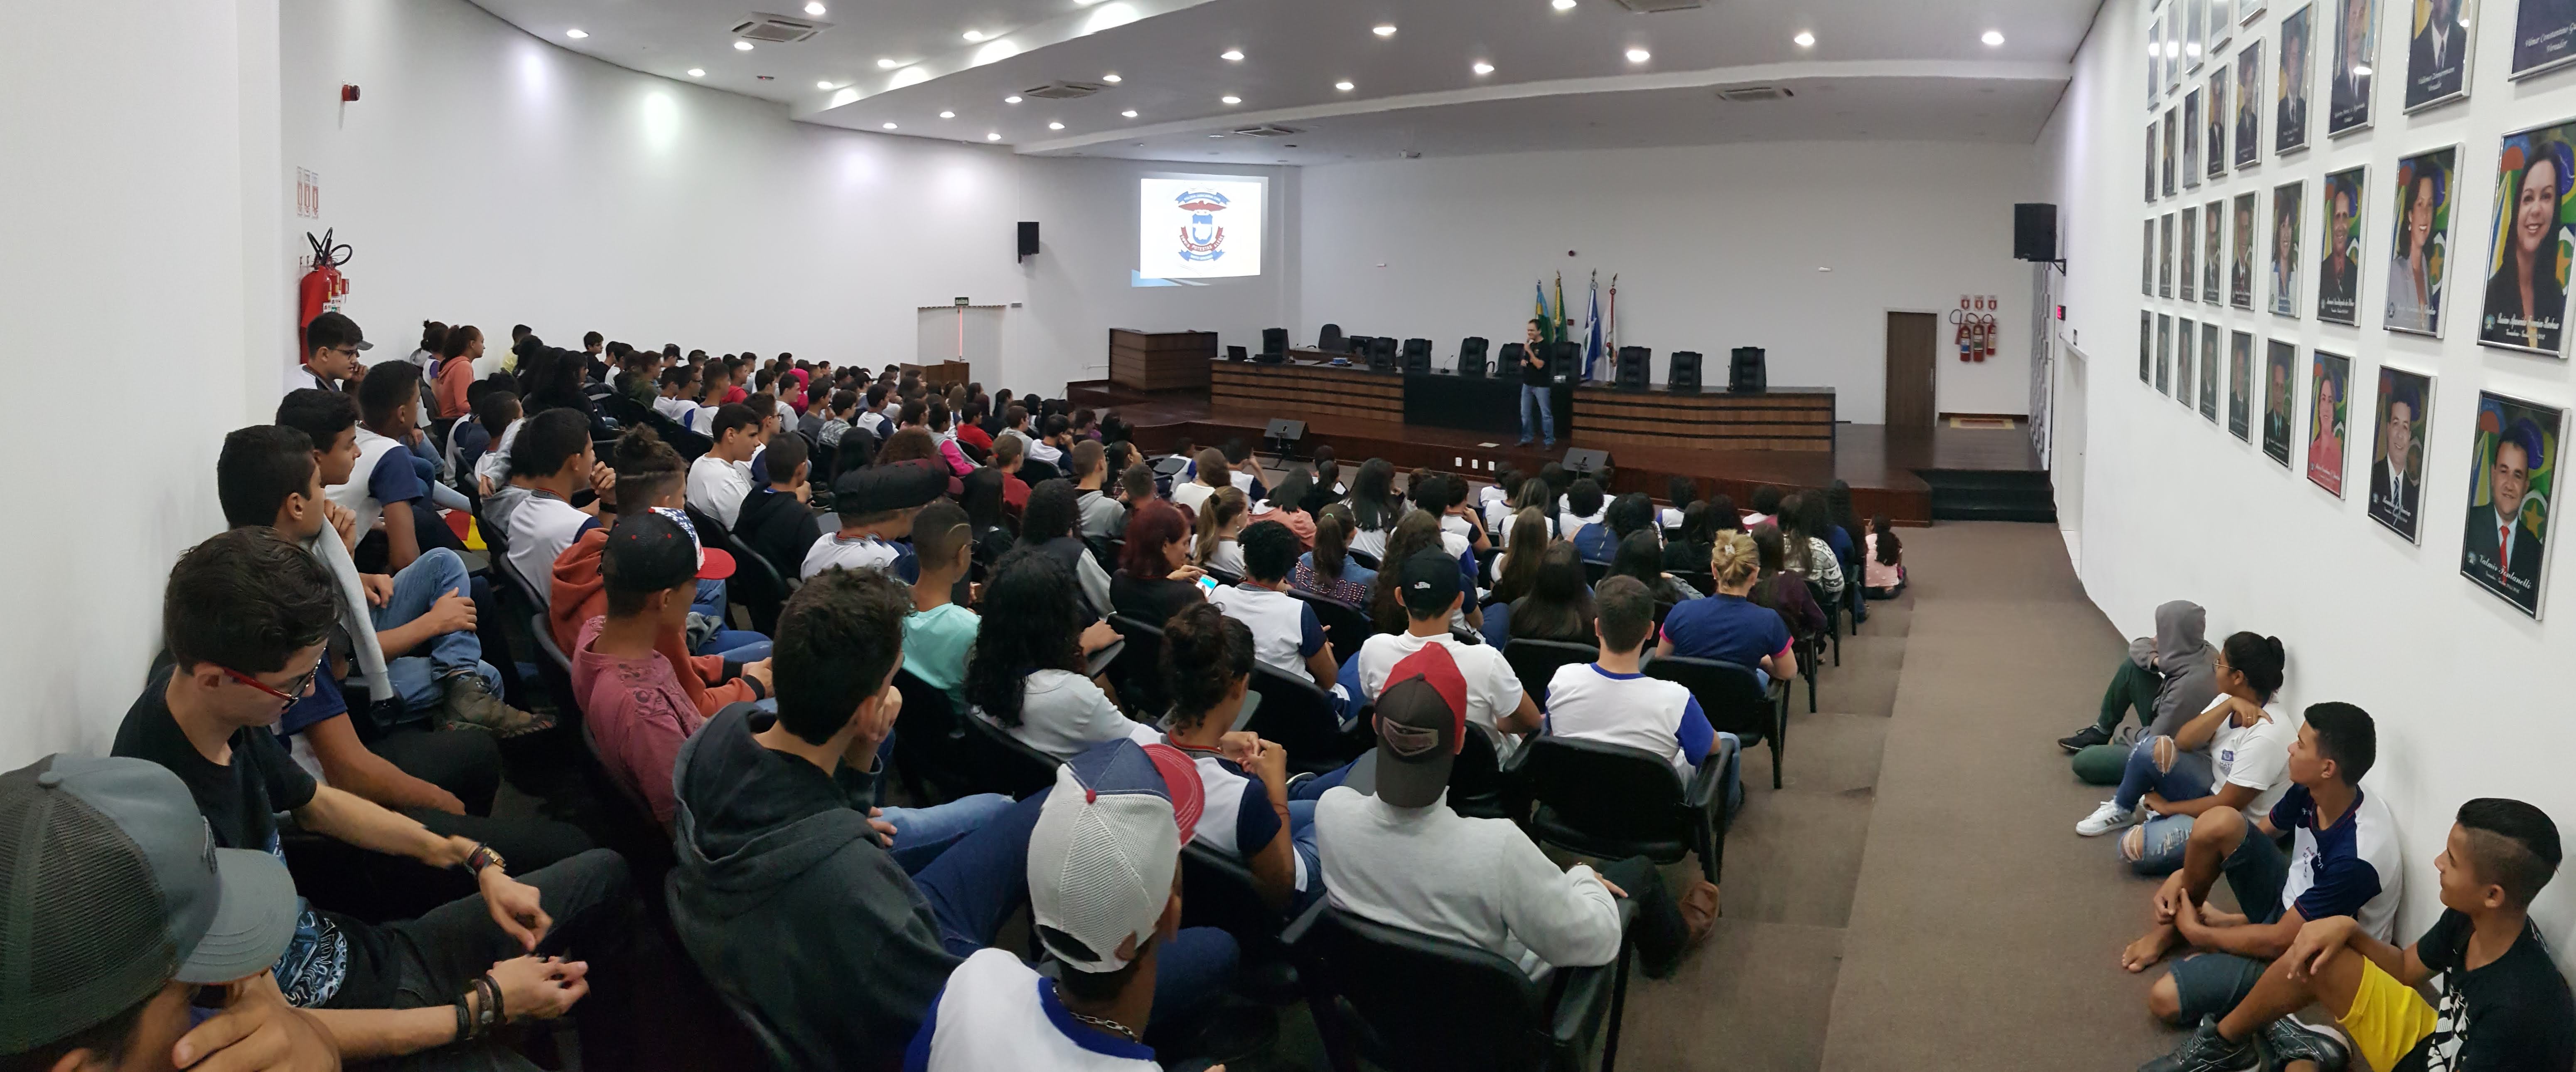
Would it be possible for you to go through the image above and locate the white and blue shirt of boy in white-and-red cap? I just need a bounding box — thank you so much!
[904,948,1162,1072]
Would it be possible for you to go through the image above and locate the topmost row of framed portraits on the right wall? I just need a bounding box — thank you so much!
[2146,0,2576,141]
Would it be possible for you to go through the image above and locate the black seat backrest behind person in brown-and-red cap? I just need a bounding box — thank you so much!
[1298,899,1551,1070]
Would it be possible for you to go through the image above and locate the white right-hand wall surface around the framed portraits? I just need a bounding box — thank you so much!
[2040,0,2576,956]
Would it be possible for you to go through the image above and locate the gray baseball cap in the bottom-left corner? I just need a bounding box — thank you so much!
[0,755,299,1054]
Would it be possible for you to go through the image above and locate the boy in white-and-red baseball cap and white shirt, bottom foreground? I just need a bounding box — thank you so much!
[904,740,1234,1072]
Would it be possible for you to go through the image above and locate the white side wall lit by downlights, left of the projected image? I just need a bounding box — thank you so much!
[278,0,1293,392]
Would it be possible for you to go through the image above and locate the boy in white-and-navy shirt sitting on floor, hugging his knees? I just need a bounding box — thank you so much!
[2120,703,2404,1023]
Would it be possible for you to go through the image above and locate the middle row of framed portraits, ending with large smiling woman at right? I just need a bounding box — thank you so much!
[2138,118,2576,358]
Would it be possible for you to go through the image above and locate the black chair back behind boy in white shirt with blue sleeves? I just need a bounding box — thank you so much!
[1512,737,1731,881]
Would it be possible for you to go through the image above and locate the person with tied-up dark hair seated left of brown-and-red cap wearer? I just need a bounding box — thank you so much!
[1162,605,1322,910]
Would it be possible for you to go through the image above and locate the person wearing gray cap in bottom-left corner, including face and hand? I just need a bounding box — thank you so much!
[0,755,340,1070]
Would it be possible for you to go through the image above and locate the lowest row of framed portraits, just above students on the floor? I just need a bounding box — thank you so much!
[2138,309,2566,618]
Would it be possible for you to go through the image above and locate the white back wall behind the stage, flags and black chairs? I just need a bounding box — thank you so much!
[1293,142,2038,423]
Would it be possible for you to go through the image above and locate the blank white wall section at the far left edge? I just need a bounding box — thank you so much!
[0,0,288,768]
